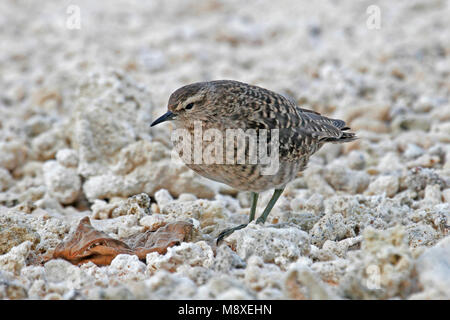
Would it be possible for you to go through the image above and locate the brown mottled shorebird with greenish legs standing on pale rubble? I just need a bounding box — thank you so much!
[151,80,357,244]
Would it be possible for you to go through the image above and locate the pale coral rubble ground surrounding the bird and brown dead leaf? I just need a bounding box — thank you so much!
[0,0,450,299]
